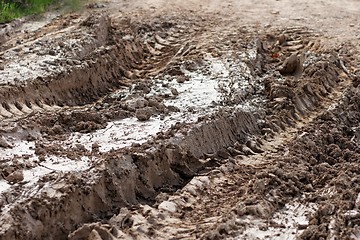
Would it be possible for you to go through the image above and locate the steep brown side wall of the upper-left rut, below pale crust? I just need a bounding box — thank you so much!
[0,15,149,118]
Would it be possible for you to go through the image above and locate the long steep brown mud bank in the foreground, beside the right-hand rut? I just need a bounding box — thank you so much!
[2,113,256,239]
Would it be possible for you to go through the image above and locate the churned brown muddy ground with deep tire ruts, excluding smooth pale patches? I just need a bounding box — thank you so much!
[0,5,359,239]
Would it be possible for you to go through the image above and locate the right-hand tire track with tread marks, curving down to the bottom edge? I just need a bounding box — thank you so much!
[70,24,354,240]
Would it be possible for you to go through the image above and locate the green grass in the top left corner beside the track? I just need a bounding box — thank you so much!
[0,0,83,23]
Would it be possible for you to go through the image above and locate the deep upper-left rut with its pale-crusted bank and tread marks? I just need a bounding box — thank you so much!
[0,14,201,122]
